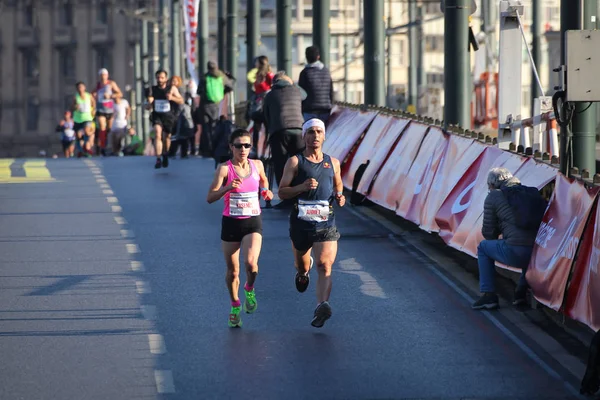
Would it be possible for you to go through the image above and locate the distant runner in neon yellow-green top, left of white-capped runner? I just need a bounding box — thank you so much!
[71,82,96,157]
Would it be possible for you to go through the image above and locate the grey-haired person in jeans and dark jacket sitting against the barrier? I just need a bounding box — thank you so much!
[472,168,537,310]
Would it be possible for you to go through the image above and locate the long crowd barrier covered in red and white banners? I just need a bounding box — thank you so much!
[323,104,600,331]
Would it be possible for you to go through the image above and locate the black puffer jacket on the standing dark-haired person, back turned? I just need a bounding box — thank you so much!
[298,61,333,113]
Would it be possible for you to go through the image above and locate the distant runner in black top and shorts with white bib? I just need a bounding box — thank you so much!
[147,69,184,168]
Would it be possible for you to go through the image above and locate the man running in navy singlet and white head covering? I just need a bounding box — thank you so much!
[279,118,346,328]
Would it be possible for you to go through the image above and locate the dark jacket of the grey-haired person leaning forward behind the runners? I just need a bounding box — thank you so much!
[263,79,304,134]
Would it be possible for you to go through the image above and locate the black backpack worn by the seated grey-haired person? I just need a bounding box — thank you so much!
[501,184,548,231]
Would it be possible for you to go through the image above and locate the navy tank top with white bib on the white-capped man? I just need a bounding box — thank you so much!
[290,153,335,230]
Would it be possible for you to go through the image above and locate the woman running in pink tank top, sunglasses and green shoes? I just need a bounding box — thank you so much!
[206,129,273,328]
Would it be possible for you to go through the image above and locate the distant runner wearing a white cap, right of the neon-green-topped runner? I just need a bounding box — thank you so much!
[92,68,123,155]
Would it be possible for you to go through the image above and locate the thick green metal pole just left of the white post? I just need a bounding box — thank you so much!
[444,0,471,128]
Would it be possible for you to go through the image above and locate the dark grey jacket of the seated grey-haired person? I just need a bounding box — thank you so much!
[481,178,537,246]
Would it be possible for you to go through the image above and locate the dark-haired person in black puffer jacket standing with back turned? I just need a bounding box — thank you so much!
[298,46,333,124]
